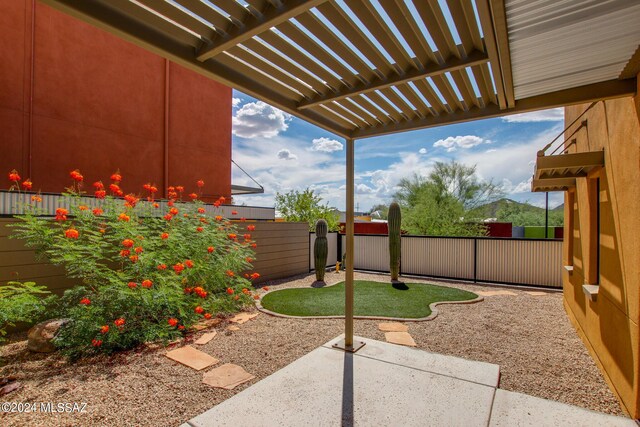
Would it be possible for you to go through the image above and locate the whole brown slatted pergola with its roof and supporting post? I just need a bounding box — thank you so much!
[40,0,640,350]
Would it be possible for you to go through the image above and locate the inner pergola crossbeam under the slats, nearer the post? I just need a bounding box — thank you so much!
[298,50,489,110]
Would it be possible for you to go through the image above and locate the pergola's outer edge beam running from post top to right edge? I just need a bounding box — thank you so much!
[351,79,637,139]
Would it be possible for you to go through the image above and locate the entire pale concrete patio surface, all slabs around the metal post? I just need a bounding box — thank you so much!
[182,337,637,427]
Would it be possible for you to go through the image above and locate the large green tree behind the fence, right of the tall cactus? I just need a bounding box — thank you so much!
[395,161,501,236]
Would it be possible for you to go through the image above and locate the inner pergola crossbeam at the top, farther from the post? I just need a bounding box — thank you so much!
[197,0,326,61]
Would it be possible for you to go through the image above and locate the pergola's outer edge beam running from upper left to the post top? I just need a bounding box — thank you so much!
[41,0,351,138]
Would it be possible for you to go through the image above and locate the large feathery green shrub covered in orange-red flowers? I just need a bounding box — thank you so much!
[9,170,259,357]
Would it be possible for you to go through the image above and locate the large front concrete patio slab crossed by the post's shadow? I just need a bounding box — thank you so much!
[184,338,495,427]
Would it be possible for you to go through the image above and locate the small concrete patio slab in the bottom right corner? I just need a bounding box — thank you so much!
[489,389,637,427]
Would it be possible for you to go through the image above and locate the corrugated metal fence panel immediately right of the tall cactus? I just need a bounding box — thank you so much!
[402,237,474,280]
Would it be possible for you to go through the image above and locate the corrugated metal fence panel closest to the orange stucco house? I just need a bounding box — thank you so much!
[477,239,562,288]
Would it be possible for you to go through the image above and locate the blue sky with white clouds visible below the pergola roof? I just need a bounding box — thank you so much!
[232,91,563,211]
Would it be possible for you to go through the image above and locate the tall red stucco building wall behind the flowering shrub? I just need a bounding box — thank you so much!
[0,0,231,201]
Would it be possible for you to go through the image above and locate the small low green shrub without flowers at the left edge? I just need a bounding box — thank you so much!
[0,282,52,342]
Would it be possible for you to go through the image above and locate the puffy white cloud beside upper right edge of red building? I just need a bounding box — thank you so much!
[232,101,292,138]
